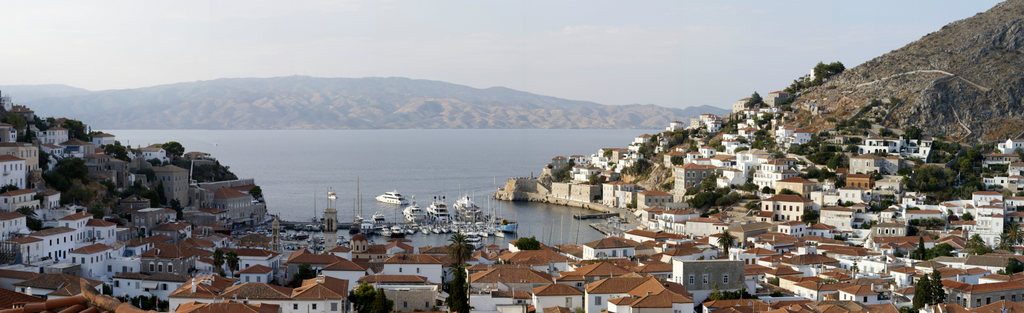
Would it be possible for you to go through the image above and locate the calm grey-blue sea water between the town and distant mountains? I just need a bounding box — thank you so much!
[108,130,644,245]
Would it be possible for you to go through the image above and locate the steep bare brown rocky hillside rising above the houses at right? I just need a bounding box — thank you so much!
[797,0,1024,141]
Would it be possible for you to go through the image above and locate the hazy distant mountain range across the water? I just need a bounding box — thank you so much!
[0,76,728,129]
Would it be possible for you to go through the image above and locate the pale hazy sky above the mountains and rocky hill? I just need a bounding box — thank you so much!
[0,0,998,107]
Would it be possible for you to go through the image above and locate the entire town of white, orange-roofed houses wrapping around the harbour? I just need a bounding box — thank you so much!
[0,71,1024,313]
